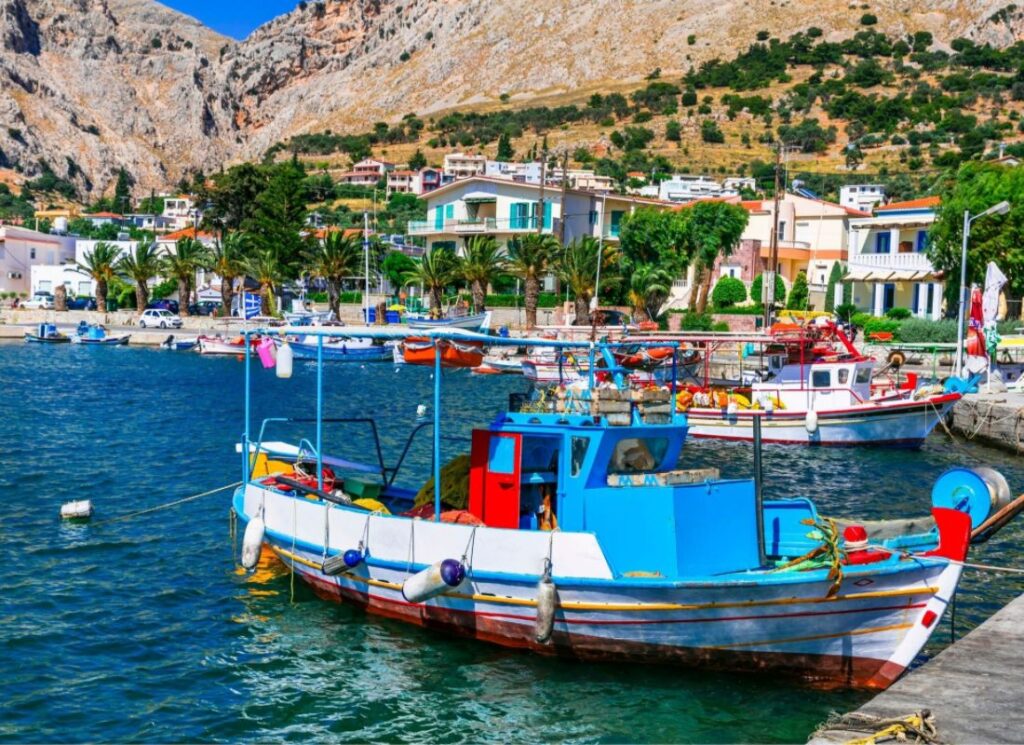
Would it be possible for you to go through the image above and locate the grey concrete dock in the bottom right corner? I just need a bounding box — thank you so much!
[810,596,1024,745]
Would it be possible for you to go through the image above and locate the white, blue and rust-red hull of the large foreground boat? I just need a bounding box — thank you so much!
[234,485,963,689]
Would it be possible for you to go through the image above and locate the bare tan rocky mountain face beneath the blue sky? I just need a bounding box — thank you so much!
[0,0,1024,194]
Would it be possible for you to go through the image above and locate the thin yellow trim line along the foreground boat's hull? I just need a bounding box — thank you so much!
[271,546,939,613]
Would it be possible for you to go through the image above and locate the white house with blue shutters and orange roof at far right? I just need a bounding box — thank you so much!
[836,196,943,320]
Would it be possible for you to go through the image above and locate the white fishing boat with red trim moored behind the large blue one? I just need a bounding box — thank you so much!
[677,323,963,447]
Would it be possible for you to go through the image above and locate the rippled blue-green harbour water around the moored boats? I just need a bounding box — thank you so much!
[6,343,1024,742]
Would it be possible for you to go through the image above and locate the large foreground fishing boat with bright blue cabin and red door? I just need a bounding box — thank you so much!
[232,330,1024,688]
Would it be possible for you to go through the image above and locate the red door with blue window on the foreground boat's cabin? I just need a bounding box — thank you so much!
[469,430,522,528]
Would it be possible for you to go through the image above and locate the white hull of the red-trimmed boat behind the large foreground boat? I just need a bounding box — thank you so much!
[686,394,959,447]
